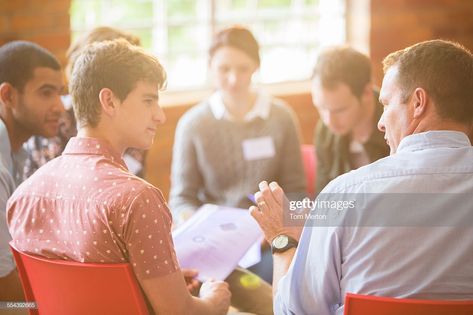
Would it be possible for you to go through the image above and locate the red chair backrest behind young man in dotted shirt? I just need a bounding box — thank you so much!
[10,243,149,315]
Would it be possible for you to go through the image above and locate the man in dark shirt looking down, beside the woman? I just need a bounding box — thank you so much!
[312,47,389,193]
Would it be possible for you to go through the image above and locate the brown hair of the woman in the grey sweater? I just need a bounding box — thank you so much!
[209,26,260,66]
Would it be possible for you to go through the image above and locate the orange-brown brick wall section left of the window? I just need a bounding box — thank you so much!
[0,0,71,64]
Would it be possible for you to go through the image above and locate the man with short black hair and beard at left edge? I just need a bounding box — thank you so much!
[0,41,64,301]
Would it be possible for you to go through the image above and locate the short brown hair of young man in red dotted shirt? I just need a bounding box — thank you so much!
[69,39,166,127]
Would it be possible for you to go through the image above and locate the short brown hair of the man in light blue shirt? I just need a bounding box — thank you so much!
[383,40,473,123]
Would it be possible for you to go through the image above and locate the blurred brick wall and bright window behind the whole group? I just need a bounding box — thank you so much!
[0,0,473,196]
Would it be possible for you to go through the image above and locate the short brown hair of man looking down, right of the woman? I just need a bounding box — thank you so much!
[312,46,371,98]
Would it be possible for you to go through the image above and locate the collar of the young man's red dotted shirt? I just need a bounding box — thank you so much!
[63,137,128,170]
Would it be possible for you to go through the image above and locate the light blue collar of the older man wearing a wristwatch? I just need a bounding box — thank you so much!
[397,130,471,153]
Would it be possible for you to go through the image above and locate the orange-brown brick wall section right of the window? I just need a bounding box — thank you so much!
[370,0,473,83]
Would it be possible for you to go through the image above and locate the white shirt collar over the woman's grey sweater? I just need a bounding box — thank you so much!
[209,91,271,122]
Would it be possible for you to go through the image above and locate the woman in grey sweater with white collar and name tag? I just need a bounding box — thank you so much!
[170,27,306,223]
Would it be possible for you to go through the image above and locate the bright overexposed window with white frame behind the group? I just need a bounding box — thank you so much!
[71,0,346,90]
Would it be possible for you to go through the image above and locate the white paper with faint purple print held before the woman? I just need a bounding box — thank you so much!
[172,204,263,281]
